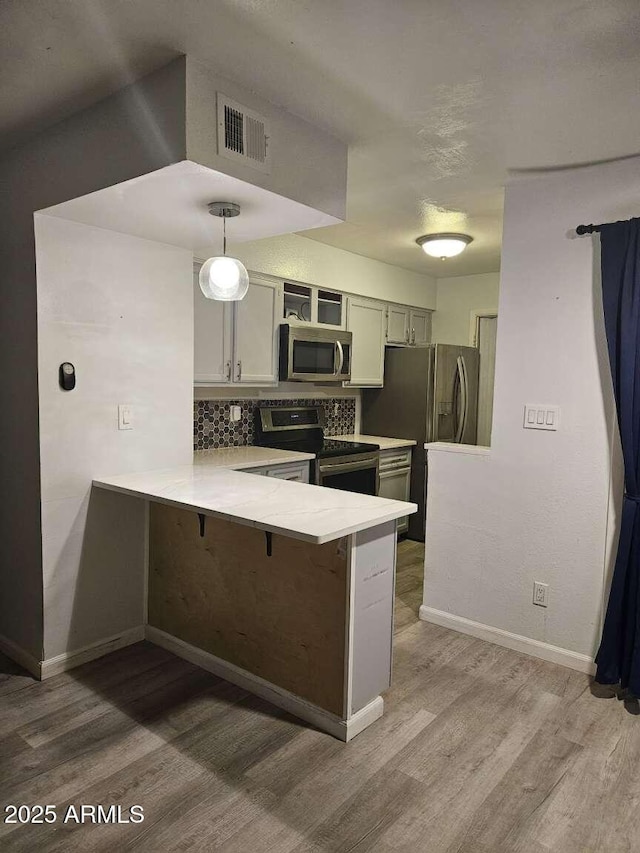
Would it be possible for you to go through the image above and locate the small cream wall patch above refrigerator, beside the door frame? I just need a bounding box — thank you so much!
[431,272,500,346]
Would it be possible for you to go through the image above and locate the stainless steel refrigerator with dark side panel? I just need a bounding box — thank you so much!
[362,344,480,541]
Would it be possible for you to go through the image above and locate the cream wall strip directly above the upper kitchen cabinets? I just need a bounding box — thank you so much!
[228,234,436,309]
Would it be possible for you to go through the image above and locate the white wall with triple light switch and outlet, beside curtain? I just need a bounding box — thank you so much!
[423,158,640,656]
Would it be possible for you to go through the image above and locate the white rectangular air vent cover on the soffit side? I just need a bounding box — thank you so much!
[218,92,271,172]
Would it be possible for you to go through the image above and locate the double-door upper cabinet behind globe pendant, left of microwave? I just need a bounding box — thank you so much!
[193,265,282,385]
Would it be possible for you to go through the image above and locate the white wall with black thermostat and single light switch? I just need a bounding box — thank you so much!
[35,214,193,659]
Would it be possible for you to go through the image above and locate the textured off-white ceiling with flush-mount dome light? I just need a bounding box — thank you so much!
[0,0,640,276]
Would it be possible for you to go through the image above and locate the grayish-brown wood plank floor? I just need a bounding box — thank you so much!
[0,543,640,853]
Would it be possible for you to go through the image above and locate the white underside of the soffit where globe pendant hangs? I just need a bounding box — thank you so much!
[40,160,339,248]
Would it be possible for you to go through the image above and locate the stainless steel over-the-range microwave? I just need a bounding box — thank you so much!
[280,323,352,382]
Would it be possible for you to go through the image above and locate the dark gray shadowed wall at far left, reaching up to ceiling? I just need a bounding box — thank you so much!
[0,58,186,661]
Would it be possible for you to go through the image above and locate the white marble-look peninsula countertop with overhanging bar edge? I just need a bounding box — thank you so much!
[93,460,418,544]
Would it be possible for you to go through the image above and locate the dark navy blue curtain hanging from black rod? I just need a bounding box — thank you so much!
[596,219,640,696]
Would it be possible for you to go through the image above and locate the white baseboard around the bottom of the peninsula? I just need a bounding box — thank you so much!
[145,625,384,742]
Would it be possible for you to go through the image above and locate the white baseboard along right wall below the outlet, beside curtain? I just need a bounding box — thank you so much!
[420,604,596,675]
